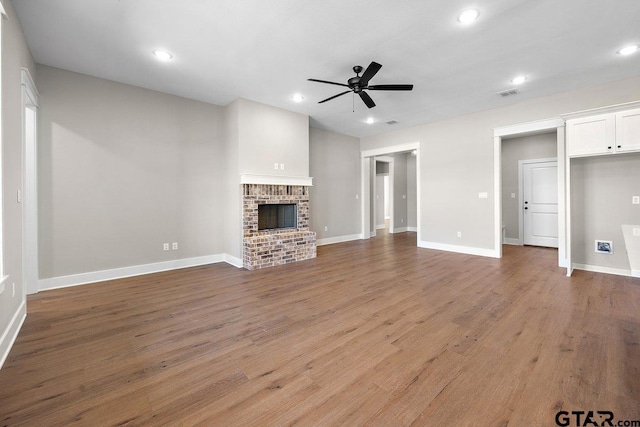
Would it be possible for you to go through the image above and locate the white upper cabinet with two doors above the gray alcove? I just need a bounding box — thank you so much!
[566,109,640,157]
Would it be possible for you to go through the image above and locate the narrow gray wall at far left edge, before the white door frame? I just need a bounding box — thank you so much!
[0,0,36,358]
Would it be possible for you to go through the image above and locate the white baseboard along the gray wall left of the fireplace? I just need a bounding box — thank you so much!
[38,254,242,290]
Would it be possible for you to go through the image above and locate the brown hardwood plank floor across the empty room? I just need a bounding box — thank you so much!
[0,233,640,426]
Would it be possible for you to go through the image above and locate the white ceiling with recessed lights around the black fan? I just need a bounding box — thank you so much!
[13,0,640,137]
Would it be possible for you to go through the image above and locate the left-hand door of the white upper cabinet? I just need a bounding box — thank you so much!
[567,114,615,157]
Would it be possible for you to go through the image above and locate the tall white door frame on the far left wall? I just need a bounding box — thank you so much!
[21,68,39,294]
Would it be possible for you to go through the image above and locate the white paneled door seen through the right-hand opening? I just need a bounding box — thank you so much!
[522,161,558,248]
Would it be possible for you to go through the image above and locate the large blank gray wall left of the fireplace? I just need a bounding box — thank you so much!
[36,66,225,278]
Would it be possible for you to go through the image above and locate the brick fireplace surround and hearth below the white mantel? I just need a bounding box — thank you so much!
[242,184,316,270]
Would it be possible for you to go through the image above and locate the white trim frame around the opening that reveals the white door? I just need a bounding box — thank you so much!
[493,117,571,267]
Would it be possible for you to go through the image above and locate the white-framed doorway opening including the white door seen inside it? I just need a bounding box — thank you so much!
[494,119,566,267]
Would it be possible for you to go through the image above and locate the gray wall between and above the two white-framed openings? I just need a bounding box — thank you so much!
[361,76,640,250]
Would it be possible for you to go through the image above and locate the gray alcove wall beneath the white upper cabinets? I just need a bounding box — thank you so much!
[571,154,640,270]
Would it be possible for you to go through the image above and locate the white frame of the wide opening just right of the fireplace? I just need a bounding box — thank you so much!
[360,141,422,242]
